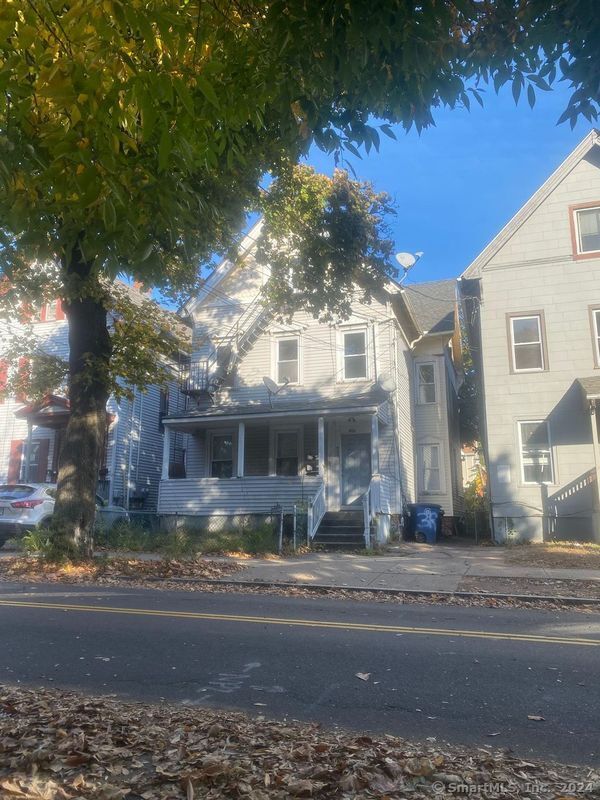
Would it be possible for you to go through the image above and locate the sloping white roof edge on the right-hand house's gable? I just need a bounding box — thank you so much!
[461,128,600,279]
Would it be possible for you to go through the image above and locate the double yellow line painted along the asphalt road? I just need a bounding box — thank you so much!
[0,600,600,647]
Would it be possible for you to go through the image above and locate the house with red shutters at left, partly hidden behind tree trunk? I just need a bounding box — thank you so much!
[0,286,185,510]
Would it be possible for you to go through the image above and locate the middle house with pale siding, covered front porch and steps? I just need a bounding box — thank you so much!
[159,223,460,544]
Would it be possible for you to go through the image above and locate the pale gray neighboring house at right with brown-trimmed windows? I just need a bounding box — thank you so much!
[460,130,600,541]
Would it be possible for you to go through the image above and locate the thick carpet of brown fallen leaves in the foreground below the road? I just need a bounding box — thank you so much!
[0,687,600,800]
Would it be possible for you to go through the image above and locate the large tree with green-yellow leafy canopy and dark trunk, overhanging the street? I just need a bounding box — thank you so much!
[0,0,600,550]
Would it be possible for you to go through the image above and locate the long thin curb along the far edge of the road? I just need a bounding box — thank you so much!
[123,576,600,606]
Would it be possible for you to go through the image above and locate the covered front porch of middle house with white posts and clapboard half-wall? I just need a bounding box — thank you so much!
[159,394,396,539]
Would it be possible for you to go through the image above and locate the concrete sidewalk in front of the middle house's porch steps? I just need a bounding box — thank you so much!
[227,542,600,592]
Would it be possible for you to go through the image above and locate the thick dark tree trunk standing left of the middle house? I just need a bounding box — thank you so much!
[53,246,112,558]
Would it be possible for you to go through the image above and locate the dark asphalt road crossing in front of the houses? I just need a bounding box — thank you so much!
[0,584,600,764]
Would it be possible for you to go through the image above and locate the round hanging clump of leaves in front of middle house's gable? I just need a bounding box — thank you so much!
[255,166,395,321]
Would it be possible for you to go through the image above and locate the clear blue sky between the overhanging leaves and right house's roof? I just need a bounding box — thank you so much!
[307,84,590,283]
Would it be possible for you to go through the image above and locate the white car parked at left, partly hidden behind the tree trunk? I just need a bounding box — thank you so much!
[0,483,129,546]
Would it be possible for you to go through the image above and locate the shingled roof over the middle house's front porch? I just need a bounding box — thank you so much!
[163,387,389,423]
